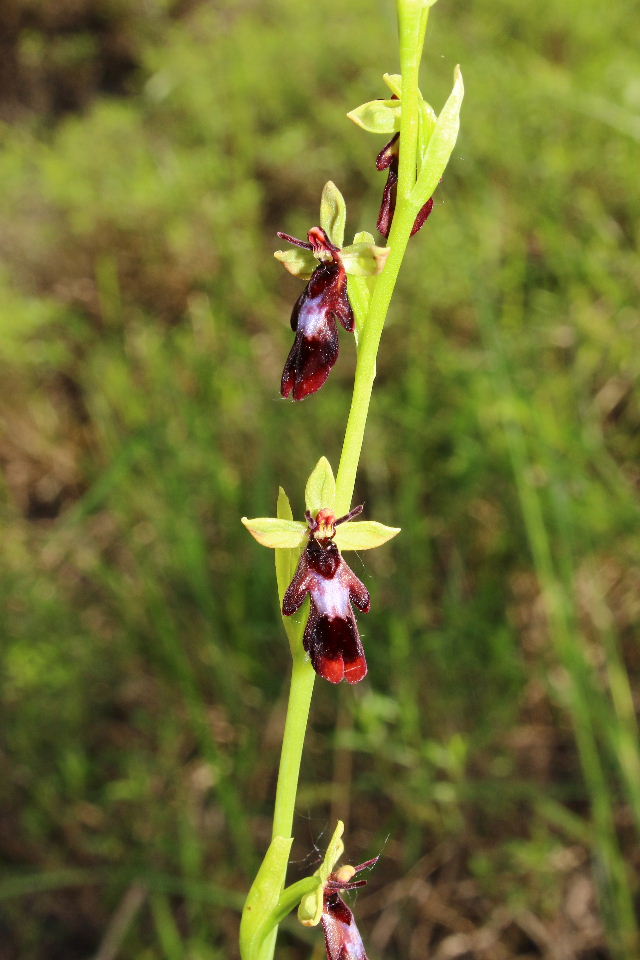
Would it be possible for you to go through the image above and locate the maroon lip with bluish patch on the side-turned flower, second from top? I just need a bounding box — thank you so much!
[278,227,354,400]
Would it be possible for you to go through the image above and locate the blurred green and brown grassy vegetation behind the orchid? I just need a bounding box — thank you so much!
[0,0,640,960]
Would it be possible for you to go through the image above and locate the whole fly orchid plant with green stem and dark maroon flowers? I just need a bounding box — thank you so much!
[240,0,464,960]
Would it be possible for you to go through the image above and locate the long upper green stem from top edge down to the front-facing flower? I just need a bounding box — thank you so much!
[336,0,429,515]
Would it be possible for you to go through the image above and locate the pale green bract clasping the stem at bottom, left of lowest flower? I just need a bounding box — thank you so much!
[240,837,293,960]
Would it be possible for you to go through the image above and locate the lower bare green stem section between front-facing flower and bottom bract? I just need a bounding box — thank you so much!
[272,642,316,840]
